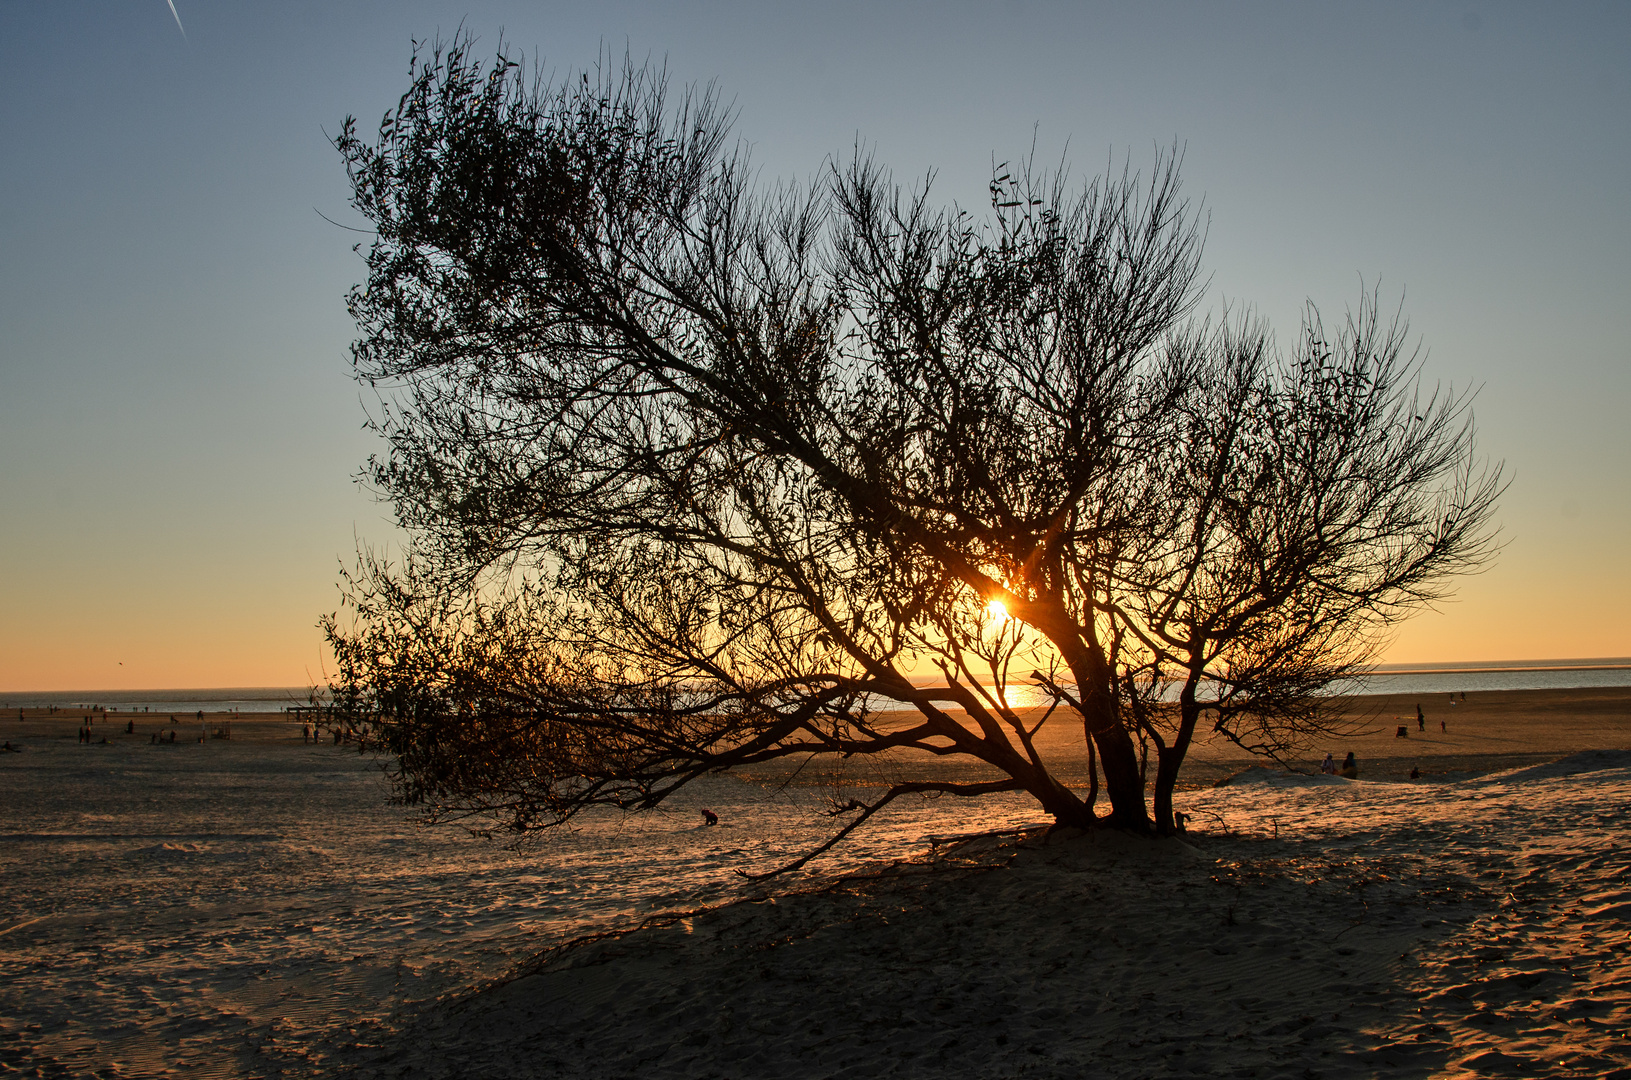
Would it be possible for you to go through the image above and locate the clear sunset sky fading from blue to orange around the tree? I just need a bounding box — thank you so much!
[0,0,1631,692]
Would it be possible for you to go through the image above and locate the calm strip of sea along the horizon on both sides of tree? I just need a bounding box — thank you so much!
[0,656,1631,713]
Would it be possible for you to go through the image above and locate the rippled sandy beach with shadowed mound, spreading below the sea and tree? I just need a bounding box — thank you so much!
[0,688,1631,1077]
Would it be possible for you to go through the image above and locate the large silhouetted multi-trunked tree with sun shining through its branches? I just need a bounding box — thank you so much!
[326,39,1501,861]
